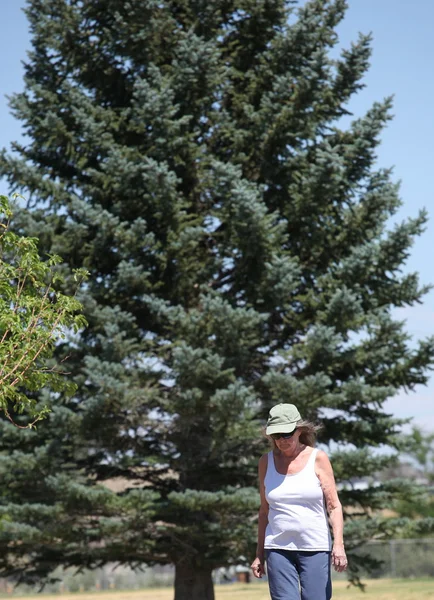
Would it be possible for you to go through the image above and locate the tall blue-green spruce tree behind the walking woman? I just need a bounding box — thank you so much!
[0,0,434,600]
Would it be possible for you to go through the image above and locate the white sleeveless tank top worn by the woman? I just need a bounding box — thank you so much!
[264,450,331,552]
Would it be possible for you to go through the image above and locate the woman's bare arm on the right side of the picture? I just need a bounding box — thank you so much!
[315,450,348,573]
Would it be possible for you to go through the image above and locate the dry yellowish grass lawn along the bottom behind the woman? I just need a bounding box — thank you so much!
[3,578,434,600]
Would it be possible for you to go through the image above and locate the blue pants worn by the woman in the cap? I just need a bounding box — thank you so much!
[265,550,332,600]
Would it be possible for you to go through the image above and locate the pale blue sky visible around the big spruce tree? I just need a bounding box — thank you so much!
[0,0,434,430]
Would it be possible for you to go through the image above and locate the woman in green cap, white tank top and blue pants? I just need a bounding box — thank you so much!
[251,404,347,600]
